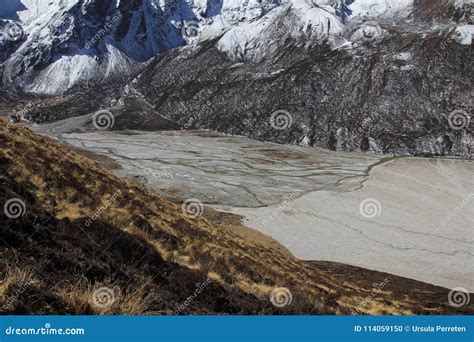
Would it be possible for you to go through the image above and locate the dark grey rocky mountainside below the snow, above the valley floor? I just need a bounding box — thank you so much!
[117,23,473,157]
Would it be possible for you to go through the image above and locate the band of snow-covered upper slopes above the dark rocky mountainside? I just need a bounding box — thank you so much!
[0,0,446,94]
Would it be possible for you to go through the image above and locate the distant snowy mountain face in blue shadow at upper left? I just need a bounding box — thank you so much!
[0,0,280,94]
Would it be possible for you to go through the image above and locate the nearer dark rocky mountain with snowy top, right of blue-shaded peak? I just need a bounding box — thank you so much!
[1,0,474,157]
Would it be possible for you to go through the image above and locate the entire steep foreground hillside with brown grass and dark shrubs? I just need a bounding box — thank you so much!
[0,120,474,314]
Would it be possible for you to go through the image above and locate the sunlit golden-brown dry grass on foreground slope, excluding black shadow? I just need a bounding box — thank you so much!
[0,120,472,314]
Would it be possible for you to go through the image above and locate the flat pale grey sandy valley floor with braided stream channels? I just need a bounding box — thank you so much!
[39,129,474,292]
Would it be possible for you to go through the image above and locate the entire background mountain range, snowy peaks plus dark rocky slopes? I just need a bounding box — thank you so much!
[0,0,474,157]
